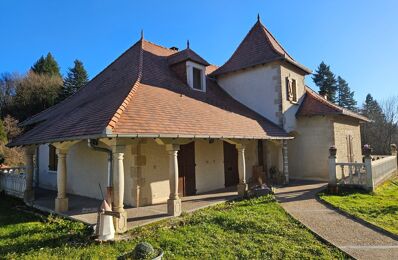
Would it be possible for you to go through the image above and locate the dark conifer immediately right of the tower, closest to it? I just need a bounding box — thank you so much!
[312,61,337,103]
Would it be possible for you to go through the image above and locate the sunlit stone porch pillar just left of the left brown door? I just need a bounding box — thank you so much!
[166,144,181,216]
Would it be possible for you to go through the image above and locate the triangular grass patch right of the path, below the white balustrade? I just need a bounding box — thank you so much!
[320,178,398,235]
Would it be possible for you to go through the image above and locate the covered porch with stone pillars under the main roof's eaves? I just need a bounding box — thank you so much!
[18,137,289,233]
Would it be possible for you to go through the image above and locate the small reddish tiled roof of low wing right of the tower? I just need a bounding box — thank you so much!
[296,87,369,122]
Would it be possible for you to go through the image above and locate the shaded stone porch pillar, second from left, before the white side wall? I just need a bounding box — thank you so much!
[55,148,68,212]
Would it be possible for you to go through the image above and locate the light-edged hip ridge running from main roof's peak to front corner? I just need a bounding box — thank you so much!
[105,39,145,132]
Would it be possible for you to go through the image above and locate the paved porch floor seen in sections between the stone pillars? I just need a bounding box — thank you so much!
[33,188,237,229]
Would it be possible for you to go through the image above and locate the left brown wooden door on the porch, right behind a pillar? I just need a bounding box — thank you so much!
[178,142,196,196]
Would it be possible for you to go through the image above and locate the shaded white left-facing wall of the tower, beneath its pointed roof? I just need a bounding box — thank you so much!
[217,63,281,127]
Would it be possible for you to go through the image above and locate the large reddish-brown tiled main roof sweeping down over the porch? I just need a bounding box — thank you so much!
[9,40,289,146]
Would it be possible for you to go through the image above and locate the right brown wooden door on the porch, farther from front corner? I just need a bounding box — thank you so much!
[224,142,239,187]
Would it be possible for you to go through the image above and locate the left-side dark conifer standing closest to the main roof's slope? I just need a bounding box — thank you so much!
[61,60,88,99]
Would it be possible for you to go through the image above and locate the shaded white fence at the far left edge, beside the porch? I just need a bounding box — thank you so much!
[0,167,26,198]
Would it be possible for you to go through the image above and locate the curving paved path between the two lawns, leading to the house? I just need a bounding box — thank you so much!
[276,182,398,259]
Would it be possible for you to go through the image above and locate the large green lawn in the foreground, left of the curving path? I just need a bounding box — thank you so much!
[0,196,347,259]
